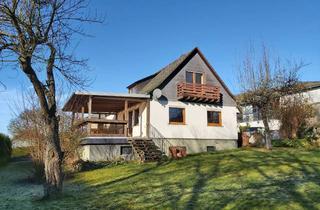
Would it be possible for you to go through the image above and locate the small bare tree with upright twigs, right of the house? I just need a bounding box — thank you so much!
[238,46,304,149]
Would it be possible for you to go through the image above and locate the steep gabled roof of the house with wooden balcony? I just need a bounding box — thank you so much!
[129,47,235,99]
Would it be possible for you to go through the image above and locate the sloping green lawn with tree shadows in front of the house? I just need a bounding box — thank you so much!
[0,148,320,209]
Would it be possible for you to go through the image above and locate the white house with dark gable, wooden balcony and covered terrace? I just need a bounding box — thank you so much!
[63,48,238,161]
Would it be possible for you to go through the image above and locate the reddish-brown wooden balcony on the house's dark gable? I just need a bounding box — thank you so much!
[177,82,220,103]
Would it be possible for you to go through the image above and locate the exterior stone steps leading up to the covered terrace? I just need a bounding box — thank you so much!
[128,138,163,162]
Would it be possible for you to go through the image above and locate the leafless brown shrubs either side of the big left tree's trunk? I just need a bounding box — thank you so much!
[8,108,84,181]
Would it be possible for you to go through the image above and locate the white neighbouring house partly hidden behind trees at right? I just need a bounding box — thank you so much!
[238,81,320,139]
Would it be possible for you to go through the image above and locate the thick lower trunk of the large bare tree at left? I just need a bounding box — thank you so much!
[44,116,63,197]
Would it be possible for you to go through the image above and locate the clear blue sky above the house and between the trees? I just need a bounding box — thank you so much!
[0,0,320,133]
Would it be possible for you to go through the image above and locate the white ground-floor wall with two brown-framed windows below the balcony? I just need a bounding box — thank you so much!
[150,100,238,140]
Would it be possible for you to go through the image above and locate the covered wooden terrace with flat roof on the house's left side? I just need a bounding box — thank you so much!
[62,92,150,137]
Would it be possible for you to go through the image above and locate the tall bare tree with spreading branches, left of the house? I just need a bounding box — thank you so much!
[0,0,100,197]
